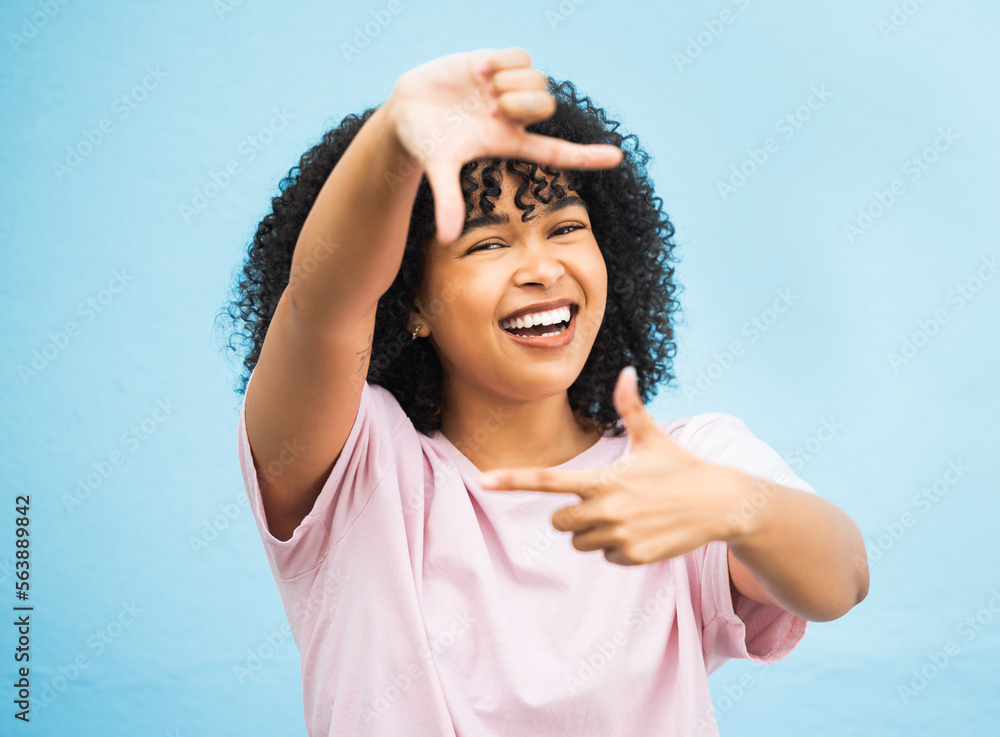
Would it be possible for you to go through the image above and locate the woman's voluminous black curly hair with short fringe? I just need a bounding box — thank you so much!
[219,77,680,436]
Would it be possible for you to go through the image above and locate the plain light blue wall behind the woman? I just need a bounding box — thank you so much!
[0,0,1000,737]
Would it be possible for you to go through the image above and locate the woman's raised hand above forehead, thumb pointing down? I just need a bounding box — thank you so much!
[386,48,623,243]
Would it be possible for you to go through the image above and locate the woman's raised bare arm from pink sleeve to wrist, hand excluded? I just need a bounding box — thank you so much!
[246,100,421,540]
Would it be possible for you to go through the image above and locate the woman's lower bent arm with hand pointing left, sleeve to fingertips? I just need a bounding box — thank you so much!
[480,367,868,621]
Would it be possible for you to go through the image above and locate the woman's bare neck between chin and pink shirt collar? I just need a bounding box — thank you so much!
[441,380,601,471]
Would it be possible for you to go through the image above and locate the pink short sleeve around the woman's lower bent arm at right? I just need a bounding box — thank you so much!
[683,412,816,673]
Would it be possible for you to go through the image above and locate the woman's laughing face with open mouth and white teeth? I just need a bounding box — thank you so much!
[411,166,607,401]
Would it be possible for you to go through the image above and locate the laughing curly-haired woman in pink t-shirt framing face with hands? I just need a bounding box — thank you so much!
[221,49,867,736]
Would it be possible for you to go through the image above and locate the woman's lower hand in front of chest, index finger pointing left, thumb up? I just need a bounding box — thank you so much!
[480,368,737,565]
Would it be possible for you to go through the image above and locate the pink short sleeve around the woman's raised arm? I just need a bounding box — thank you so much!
[238,373,400,580]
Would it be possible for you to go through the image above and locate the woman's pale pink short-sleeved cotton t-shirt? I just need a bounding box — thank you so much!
[239,379,815,737]
